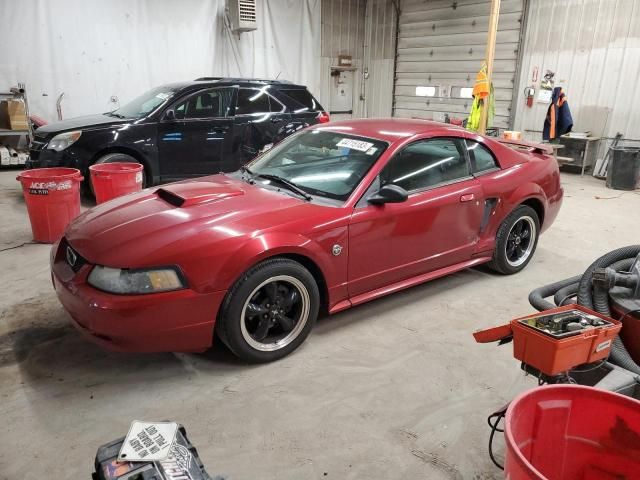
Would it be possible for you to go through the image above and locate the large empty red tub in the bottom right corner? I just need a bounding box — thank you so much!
[504,385,640,480]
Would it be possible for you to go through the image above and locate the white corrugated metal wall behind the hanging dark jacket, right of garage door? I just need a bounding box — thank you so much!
[515,0,640,148]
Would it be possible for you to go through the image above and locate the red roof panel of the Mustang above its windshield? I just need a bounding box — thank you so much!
[311,118,465,143]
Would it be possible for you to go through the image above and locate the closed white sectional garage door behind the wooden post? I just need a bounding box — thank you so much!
[394,0,525,128]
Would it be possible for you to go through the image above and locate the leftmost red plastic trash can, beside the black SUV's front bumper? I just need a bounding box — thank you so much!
[16,168,82,243]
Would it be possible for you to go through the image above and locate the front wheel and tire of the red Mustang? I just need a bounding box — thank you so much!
[216,258,320,363]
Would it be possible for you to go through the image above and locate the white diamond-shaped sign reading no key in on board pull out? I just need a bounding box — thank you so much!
[118,420,178,462]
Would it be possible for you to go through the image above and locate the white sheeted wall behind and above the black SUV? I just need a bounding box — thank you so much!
[0,0,320,120]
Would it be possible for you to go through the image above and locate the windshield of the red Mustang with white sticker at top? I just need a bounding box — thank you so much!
[247,129,387,201]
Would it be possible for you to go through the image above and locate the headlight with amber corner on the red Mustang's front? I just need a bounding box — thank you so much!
[87,265,186,295]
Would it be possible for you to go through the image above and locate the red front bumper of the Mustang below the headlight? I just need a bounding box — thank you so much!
[51,242,226,352]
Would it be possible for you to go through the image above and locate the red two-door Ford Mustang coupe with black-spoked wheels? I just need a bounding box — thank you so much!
[51,119,563,362]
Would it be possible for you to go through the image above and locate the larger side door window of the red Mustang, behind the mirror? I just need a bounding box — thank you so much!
[380,138,470,192]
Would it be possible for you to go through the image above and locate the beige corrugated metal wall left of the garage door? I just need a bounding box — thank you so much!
[319,0,396,118]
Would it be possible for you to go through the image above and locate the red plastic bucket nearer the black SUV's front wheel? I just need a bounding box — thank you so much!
[89,162,143,203]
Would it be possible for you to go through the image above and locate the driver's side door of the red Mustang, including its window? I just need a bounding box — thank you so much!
[349,137,483,296]
